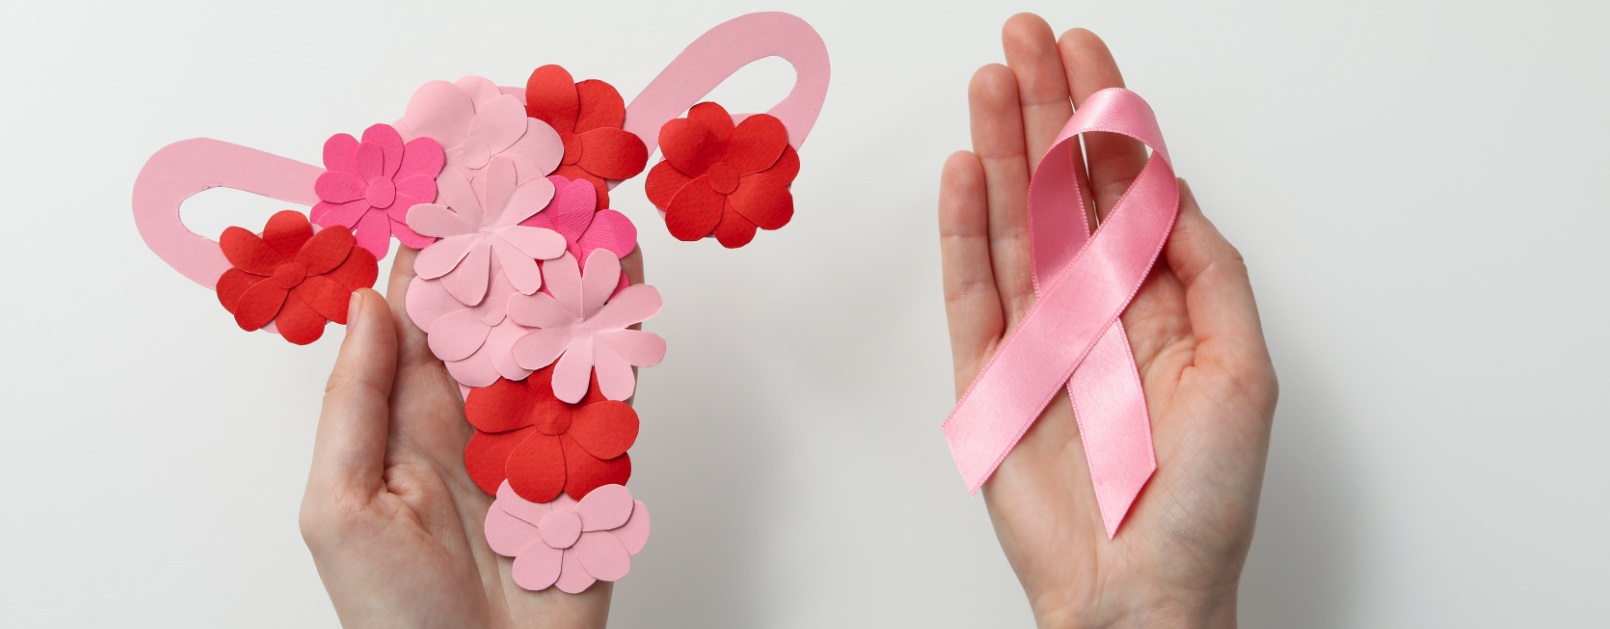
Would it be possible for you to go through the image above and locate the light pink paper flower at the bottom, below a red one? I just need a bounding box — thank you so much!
[483,483,649,594]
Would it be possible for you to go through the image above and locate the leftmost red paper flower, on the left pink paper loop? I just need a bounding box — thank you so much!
[217,209,378,344]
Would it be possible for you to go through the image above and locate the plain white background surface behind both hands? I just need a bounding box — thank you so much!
[0,0,1610,627]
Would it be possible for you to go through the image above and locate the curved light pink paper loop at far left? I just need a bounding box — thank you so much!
[134,138,324,290]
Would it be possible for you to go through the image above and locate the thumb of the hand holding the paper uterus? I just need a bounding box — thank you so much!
[308,288,398,495]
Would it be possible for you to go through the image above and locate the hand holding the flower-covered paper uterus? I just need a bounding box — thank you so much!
[301,248,642,627]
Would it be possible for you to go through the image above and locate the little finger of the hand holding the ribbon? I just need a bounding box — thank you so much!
[939,151,1005,394]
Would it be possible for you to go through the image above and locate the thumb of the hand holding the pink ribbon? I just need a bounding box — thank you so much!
[1162,179,1269,368]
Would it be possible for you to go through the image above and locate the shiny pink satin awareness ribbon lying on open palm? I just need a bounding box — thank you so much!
[943,88,1180,539]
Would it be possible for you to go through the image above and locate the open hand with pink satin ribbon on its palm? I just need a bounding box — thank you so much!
[939,14,1278,627]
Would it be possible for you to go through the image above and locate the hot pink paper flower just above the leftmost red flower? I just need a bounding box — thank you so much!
[311,124,446,259]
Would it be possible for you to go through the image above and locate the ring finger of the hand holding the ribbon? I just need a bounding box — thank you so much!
[968,64,1034,322]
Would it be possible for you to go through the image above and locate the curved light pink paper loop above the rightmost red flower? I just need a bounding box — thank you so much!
[625,13,829,153]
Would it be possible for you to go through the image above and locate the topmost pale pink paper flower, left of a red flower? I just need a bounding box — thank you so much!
[396,76,565,182]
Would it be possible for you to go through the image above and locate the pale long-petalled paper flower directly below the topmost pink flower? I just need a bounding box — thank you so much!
[407,156,565,306]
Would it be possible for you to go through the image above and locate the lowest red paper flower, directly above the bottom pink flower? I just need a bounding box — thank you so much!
[464,368,638,502]
